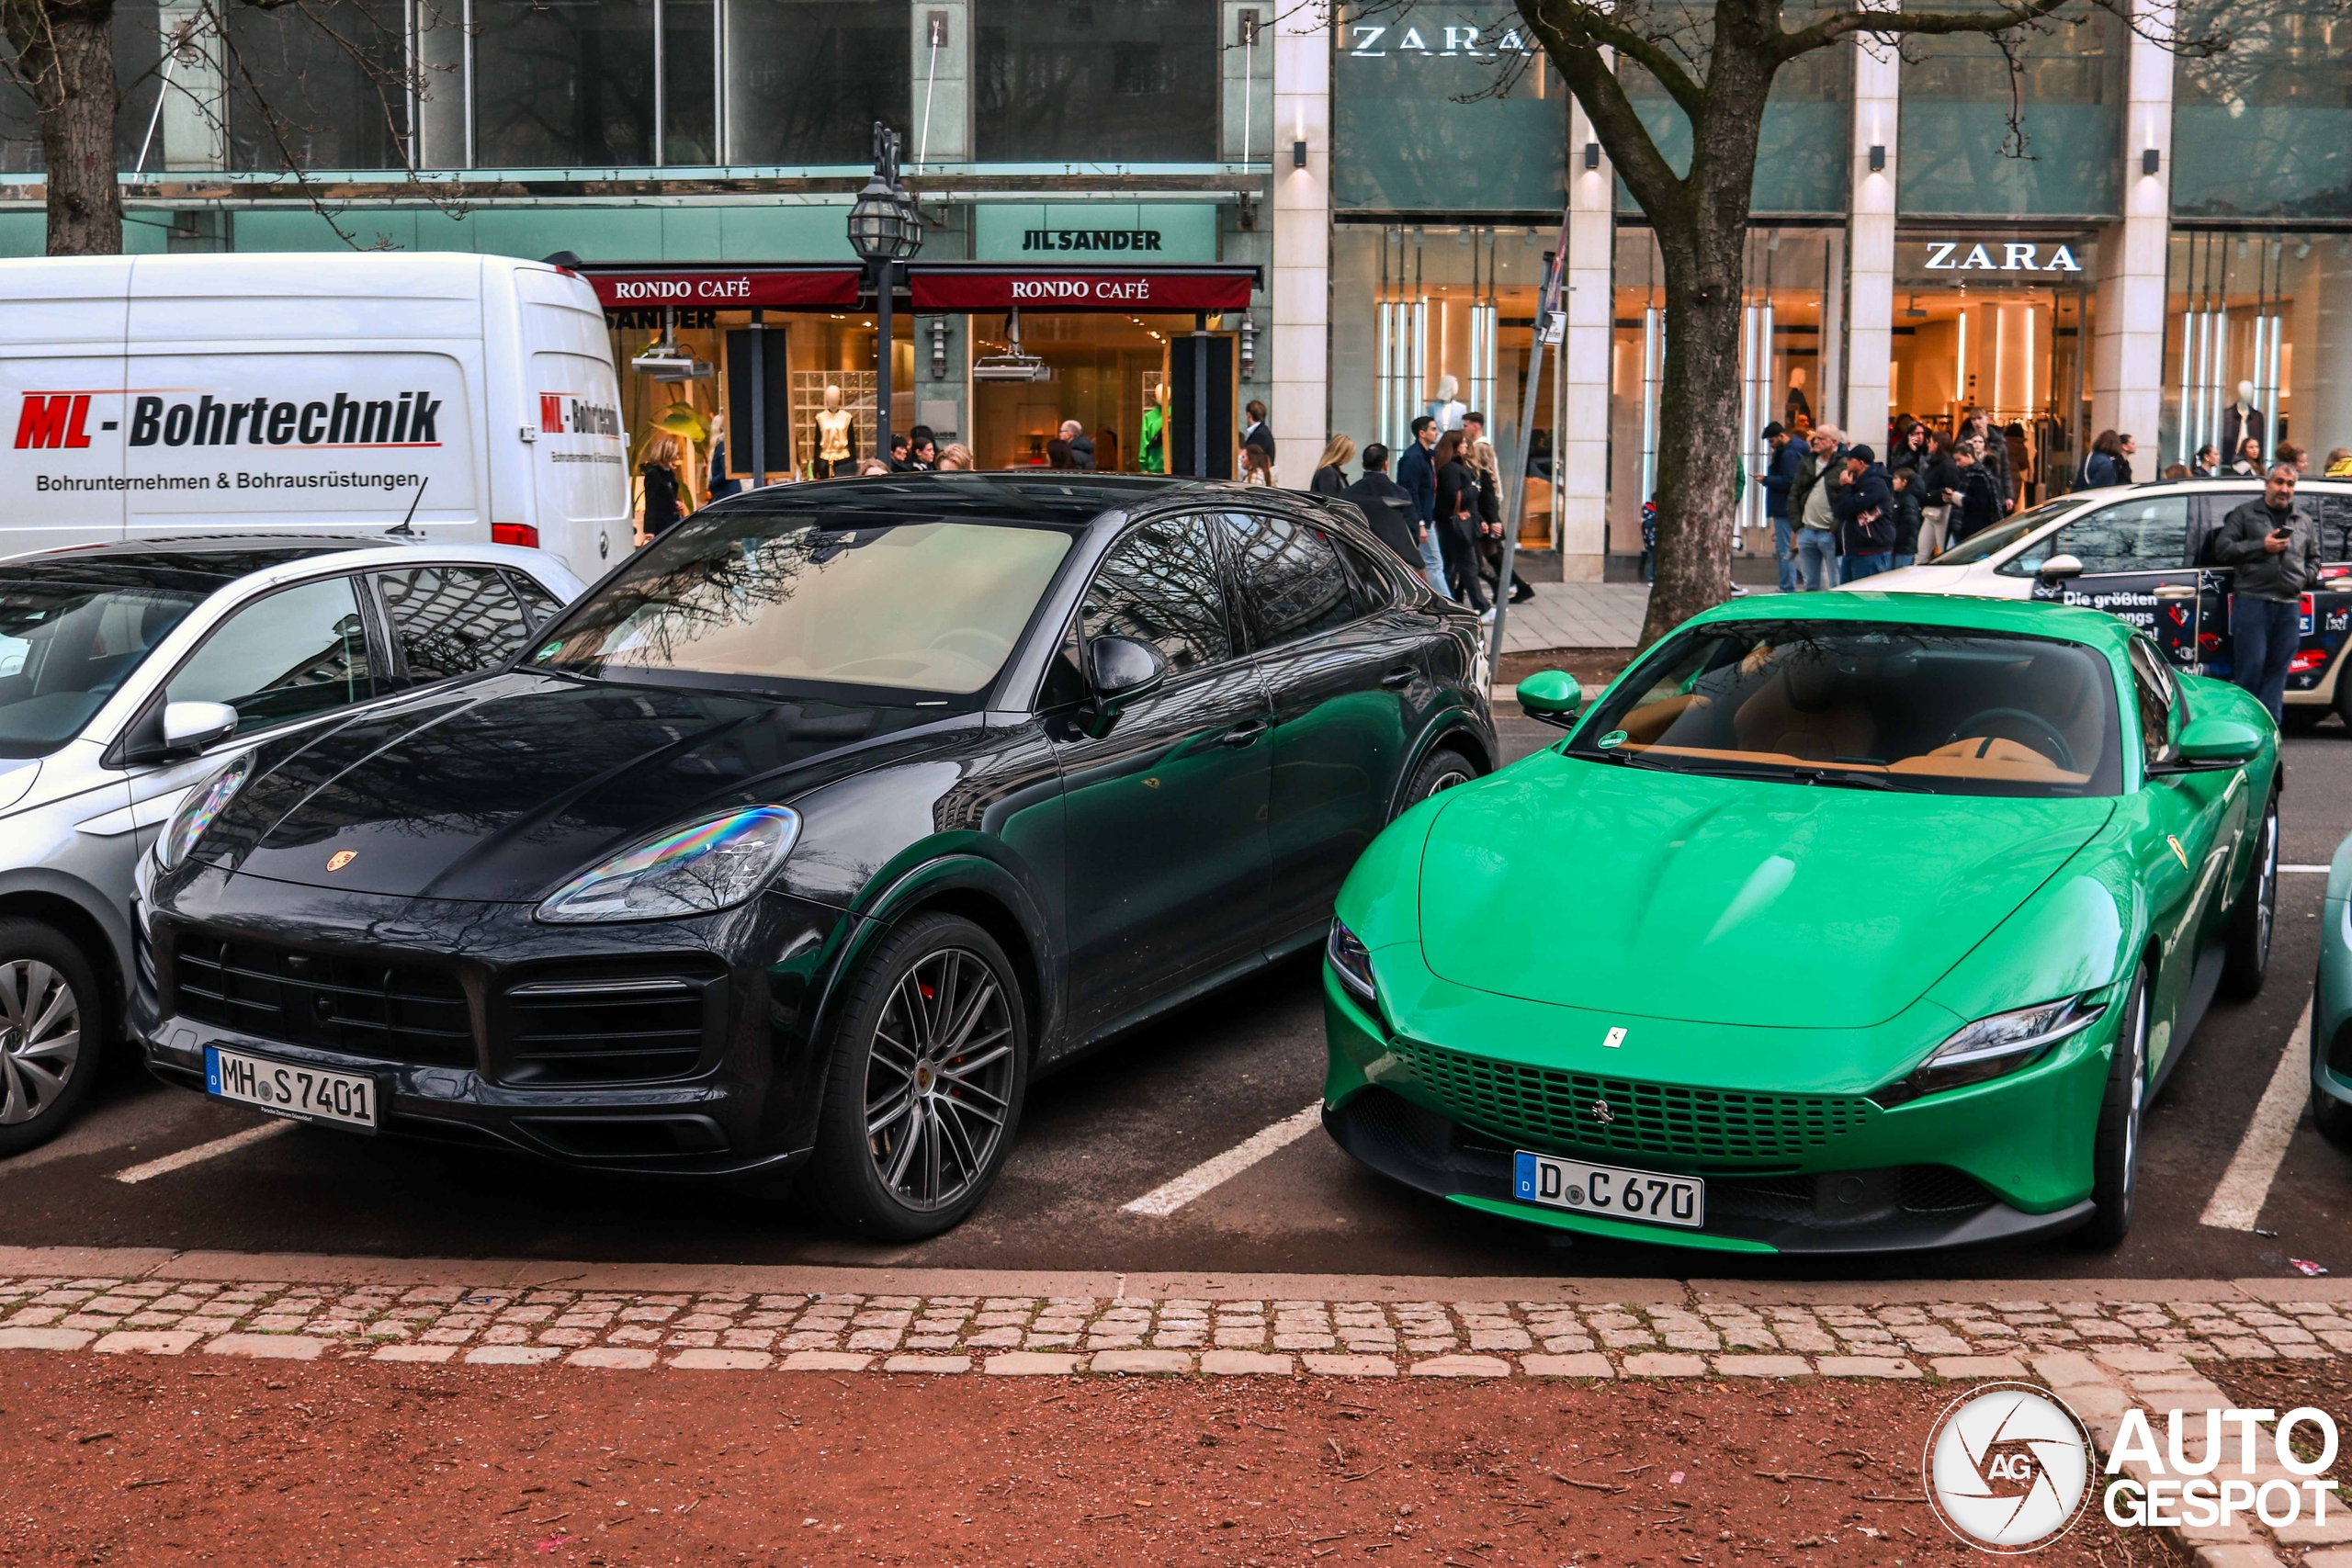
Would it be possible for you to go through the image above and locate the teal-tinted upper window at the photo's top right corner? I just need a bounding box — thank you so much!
[2173,0,2352,219]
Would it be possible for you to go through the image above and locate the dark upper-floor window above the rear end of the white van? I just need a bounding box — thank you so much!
[473,0,654,169]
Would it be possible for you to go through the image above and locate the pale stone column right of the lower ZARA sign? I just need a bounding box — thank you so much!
[2091,0,2173,444]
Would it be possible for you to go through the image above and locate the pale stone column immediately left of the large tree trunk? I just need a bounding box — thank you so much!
[1536,85,1616,583]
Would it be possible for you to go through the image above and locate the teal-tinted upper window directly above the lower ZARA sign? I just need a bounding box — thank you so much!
[1898,0,2131,216]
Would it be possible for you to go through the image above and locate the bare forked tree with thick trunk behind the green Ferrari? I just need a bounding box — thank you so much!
[1512,0,2221,644]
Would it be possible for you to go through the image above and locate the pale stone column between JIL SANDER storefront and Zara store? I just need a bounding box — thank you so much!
[1270,5,1331,456]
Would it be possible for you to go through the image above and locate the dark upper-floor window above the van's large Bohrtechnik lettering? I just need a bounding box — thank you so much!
[227,0,409,169]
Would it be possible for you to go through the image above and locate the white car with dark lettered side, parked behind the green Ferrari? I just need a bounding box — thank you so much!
[1847,478,2352,728]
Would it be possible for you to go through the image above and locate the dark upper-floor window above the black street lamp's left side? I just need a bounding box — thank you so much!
[727,0,917,167]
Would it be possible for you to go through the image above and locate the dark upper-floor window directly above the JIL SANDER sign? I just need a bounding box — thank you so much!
[973,0,1221,164]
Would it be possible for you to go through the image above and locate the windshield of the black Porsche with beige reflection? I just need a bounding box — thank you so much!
[532,513,1072,696]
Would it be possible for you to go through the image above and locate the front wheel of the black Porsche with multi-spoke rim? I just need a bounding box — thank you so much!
[809,915,1028,1241]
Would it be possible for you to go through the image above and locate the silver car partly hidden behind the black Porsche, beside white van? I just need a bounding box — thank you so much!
[0,534,583,1156]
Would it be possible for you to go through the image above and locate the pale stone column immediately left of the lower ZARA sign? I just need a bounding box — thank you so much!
[1844,38,1903,446]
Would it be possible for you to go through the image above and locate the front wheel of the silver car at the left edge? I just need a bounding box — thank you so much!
[0,919,108,1156]
